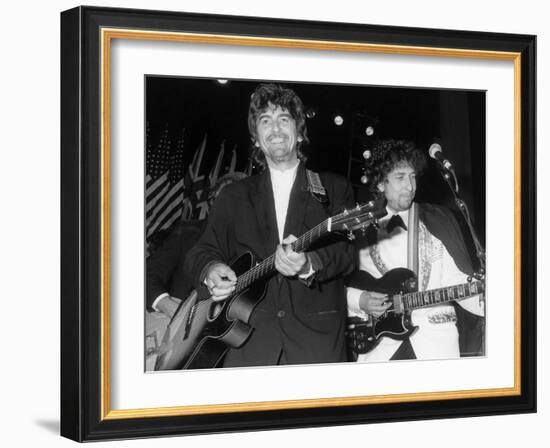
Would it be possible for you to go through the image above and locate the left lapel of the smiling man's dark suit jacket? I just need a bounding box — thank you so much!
[250,168,279,259]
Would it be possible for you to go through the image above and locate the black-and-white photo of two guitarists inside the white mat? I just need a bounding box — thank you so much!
[145,76,485,370]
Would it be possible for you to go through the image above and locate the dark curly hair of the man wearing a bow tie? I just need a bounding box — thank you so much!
[365,140,426,198]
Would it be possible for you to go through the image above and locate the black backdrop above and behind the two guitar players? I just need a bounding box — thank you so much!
[145,76,485,244]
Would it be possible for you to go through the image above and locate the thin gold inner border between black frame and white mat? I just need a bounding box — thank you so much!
[100,28,521,420]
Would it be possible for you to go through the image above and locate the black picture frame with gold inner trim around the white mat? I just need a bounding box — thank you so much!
[61,7,537,441]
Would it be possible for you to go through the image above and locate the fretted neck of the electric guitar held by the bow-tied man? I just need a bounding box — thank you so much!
[398,281,484,311]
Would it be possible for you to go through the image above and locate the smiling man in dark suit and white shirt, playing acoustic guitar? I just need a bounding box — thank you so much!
[185,84,354,367]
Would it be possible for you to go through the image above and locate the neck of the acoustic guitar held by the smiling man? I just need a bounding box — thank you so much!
[234,218,332,294]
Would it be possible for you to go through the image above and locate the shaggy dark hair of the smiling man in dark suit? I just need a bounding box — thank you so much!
[248,84,309,169]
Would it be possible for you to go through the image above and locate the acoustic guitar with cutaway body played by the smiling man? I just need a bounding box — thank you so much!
[155,201,387,370]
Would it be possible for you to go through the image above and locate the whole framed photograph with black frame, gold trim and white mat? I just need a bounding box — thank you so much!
[61,7,536,441]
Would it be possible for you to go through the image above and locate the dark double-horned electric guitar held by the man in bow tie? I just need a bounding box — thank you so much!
[346,268,485,354]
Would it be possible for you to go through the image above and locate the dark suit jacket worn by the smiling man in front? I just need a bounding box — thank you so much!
[185,166,354,366]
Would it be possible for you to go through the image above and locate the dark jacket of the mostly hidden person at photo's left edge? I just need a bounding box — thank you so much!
[145,221,205,311]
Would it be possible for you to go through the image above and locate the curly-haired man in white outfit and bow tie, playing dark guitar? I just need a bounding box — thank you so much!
[347,140,483,361]
